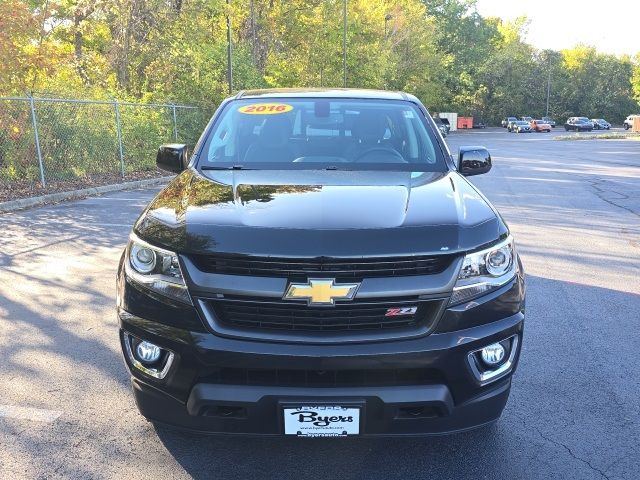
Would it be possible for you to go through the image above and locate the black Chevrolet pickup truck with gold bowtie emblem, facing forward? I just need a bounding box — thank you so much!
[117,90,525,437]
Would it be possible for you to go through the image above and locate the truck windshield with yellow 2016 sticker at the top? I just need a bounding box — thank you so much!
[198,98,447,171]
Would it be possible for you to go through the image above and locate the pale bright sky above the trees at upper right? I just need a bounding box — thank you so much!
[477,0,640,55]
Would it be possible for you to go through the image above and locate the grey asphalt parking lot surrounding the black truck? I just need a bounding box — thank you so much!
[0,129,640,480]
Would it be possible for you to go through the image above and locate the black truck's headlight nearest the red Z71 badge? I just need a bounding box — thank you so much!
[449,236,517,305]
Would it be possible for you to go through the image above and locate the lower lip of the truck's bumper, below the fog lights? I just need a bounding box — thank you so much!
[132,368,511,436]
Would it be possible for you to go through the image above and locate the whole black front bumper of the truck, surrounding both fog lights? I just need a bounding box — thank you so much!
[119,260,524,436]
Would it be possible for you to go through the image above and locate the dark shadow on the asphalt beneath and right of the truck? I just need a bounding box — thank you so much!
[155,276,640,479]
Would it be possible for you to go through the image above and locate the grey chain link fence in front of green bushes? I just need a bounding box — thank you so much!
[0,97,209,202]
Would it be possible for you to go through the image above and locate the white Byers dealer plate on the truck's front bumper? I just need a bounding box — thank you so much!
[284,405,360,437]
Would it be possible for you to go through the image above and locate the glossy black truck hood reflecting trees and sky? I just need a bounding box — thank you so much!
[134,169,507,257]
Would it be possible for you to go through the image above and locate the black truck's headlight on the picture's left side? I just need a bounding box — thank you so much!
[125,233,192,305]
